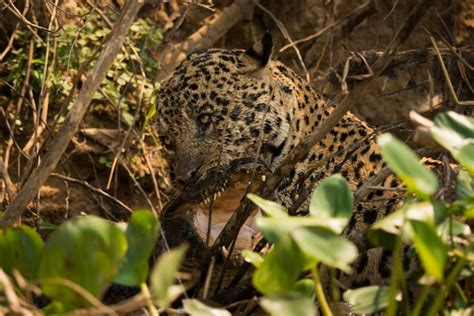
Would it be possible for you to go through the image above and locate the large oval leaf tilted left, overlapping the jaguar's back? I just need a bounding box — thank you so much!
[377,134,438,199]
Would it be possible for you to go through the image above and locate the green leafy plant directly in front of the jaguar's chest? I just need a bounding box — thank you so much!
[244,175,357,315]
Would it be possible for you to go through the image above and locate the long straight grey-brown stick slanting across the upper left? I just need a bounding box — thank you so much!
[0,0,143,227]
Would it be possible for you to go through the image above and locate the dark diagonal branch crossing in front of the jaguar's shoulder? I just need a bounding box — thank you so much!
[212,0,434,253]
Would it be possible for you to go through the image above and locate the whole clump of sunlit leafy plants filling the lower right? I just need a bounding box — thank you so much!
[243,112,474,315]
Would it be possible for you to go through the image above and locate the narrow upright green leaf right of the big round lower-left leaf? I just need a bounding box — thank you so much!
[114,211,159,286]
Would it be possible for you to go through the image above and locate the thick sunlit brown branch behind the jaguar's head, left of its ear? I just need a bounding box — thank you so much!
[155,0,253,81]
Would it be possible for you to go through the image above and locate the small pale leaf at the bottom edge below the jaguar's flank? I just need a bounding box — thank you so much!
[343,286,390,314]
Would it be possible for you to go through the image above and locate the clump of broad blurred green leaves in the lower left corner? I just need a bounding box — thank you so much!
[0,211,186,313]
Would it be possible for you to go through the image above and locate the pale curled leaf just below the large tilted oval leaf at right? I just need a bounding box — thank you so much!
[367,201,440,249]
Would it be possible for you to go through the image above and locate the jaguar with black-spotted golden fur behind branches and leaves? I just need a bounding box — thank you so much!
[157,37,412,286]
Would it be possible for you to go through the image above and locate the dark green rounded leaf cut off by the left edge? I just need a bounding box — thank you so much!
[0,226,44,279]
